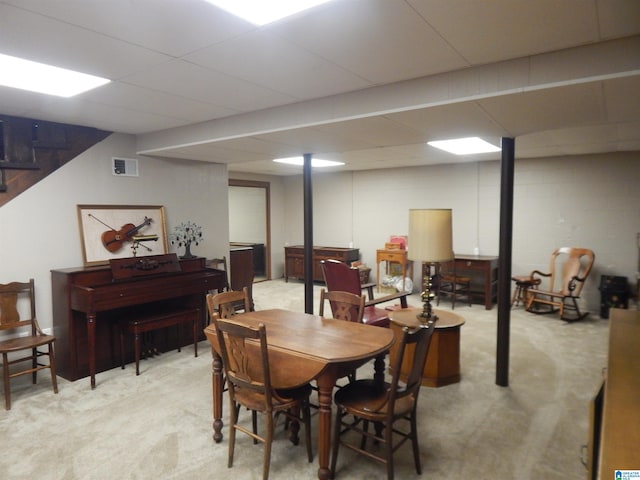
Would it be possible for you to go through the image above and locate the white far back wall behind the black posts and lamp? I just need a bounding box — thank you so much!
[280,153,640,311]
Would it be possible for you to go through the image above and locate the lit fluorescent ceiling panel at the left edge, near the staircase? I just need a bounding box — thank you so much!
[0,54,111,97]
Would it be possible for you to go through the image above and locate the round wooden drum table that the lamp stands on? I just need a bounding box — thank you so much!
[389,308,464,387]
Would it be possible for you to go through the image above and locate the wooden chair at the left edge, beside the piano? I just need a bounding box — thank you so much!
[0,278,58,410]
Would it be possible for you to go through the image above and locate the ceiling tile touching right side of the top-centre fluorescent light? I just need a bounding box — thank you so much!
[270,0,468,84]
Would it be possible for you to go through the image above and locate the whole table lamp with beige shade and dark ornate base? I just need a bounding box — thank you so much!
[407,209,453,323]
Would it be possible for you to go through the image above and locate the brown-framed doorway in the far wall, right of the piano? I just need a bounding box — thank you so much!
[229,179,271,282]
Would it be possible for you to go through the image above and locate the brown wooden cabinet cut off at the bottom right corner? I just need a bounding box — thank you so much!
[587,308,640,480]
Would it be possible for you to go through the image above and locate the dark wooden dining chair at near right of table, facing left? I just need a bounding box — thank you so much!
[331,322,435,480]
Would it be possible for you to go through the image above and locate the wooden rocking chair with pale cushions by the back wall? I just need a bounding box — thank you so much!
[527,247,595,321]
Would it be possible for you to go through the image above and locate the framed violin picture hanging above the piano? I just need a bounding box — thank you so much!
[78,205,168,265]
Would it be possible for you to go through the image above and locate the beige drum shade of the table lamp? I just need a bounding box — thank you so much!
[407,209,453,262]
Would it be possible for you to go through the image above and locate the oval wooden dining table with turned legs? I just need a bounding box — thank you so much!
[204,309,395,480]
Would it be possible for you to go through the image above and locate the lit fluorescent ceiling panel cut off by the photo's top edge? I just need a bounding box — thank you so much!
[207,0,331,25]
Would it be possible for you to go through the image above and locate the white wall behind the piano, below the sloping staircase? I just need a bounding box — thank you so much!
[0,134,229,328]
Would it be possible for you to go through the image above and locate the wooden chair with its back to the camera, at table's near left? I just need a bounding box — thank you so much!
[213,317,313,480]
